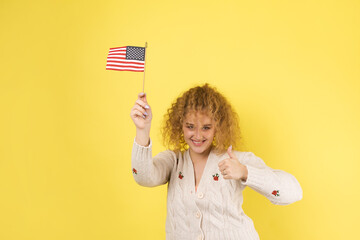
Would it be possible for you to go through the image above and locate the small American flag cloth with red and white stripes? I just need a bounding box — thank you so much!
[106,46,145,72]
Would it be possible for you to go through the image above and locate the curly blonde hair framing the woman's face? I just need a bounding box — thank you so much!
[161,83,240,153]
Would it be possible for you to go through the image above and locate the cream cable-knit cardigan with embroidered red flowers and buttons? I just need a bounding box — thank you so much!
[131,140,302,240]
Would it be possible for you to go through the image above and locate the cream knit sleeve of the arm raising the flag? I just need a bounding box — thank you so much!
[131,140,176,187]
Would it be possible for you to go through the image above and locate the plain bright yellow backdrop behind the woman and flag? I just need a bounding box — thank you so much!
[0,0,360,240]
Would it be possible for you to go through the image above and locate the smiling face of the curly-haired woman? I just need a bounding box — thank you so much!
[182,112,215,155]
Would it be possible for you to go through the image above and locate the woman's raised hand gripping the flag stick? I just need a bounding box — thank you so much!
[130,93,152,131]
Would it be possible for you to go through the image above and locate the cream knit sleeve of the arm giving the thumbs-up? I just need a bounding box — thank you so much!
[240,152,303,205]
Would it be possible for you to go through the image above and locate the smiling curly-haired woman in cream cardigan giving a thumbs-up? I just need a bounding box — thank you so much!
[130,84,302,240]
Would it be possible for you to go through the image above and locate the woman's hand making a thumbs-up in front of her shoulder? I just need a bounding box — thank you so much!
[218,146,248,181]
